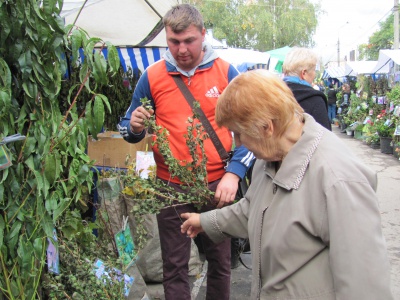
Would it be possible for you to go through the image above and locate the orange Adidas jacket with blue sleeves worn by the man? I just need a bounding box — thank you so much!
[118,43,254,183]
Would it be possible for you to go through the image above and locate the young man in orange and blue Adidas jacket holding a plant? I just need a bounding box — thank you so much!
[118,4,254,300]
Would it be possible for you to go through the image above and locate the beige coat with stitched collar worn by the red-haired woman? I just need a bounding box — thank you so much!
[201,114,393,300]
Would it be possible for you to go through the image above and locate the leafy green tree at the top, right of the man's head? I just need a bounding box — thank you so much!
[184,0,321,51]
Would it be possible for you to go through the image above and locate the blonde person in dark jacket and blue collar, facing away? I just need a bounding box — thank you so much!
[282,47,332,130]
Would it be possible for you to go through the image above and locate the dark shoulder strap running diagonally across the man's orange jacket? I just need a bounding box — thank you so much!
[172,75,230,162]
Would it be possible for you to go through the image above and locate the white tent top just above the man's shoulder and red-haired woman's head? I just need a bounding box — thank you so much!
[215,48,270,72]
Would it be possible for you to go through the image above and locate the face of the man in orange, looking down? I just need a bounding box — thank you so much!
[165,25,206,71]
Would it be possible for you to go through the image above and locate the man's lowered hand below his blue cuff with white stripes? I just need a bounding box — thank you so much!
[214,172,240,208]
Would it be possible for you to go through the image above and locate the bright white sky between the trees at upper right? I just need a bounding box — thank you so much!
[311,0,394,64]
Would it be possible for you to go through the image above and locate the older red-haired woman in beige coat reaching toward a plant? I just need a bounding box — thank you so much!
[181,70,393,300]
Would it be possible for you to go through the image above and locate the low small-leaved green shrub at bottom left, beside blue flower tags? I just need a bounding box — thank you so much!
[42,210,124,299]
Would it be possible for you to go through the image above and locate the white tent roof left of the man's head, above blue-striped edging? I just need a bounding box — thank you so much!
[61,0,180,47]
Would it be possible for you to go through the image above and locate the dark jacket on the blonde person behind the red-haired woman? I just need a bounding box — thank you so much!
[286,82,332,130]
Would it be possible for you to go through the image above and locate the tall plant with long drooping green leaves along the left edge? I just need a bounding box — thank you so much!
[0,0,120,300]
